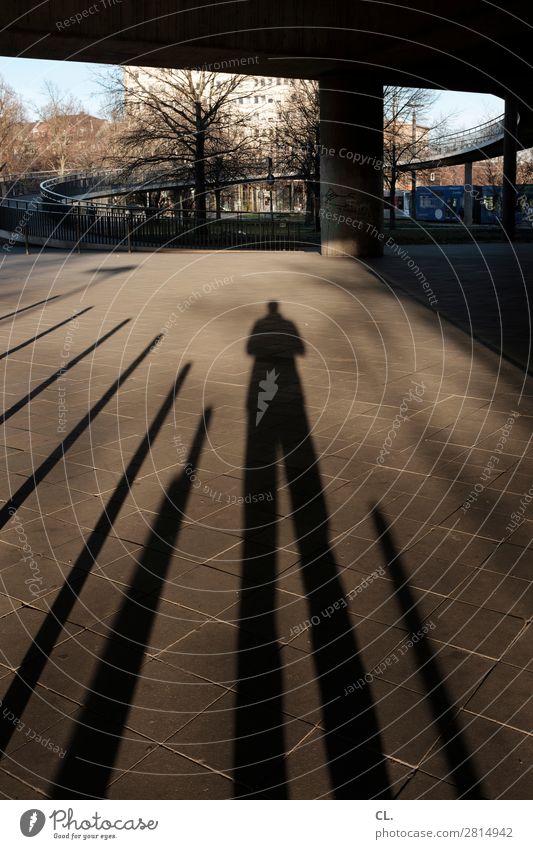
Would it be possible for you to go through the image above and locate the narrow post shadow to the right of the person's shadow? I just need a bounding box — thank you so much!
[373,507,485,799]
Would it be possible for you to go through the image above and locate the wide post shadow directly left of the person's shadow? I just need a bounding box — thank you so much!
[50,409,211,799]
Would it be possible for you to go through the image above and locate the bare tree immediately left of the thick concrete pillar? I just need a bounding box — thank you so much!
[276,80,320,227]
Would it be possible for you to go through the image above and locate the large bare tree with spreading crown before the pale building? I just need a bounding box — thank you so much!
[104,67,260,219]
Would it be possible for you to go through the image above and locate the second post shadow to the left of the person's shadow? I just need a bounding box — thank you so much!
[0,364,190,757]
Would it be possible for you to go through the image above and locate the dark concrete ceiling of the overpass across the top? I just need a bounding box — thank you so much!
[0,0,533,106]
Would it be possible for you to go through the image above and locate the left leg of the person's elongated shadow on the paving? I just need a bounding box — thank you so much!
[233,384,288,799]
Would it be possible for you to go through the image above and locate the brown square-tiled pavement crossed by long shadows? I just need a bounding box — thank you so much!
[0,246,533,799]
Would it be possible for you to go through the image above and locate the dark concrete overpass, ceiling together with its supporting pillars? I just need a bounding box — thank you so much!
[0,0,533,248]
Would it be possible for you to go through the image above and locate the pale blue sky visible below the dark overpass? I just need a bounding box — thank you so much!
[0,57,503,130]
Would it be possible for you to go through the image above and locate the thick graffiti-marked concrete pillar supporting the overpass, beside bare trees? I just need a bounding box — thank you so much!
[319,75,385,256]
